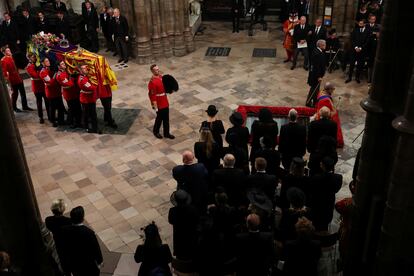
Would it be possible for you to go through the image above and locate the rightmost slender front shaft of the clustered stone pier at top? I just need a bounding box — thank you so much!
[173,0,187,57]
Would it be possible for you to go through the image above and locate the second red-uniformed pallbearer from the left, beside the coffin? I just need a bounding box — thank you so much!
[26,53,50,124]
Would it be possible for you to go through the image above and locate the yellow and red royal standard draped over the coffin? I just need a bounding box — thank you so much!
[64,49,118,97]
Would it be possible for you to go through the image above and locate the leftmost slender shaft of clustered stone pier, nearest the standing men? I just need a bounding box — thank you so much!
[134,0,151,64]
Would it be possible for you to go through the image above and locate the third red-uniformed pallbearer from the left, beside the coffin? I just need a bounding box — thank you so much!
[39,58,65,127]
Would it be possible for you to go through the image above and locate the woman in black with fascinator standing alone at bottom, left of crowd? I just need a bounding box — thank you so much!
[134,222,172,276]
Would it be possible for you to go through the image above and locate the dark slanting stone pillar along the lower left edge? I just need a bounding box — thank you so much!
[0,64,55,276]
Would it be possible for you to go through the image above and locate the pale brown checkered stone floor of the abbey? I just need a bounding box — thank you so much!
[16,23,368,275]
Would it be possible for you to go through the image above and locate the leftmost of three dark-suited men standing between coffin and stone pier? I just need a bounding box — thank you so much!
[82,2,99,53]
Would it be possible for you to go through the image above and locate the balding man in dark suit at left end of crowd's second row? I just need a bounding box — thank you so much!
[172,151,208,214]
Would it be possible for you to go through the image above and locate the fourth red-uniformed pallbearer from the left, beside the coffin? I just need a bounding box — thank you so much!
[56,60,82,128]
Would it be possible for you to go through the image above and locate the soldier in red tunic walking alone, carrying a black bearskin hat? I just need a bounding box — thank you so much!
[148,64,175,139]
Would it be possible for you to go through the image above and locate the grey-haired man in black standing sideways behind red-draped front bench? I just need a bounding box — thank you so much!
[306,39,326,107]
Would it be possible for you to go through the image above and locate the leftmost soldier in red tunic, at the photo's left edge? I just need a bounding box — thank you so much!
[1,47,33,112]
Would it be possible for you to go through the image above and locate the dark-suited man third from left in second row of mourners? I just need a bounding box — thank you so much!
[246,157,277,203]
